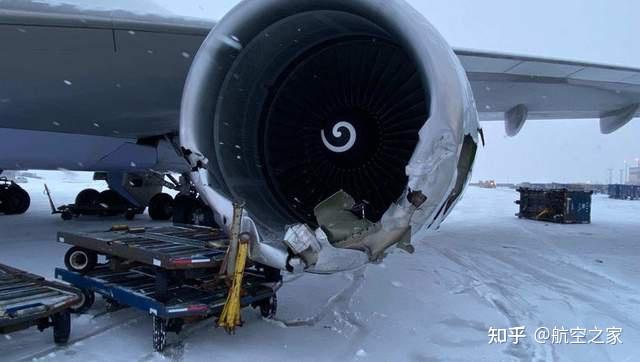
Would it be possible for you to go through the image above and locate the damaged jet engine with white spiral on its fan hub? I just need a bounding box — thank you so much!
[180,0,479,270]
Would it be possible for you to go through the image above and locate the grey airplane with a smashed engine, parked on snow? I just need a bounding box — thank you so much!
[0,0,640,273]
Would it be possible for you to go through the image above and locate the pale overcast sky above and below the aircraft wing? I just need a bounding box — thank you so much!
[45,0,640,182]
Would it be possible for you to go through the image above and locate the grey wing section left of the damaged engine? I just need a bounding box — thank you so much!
[0,2,214,139]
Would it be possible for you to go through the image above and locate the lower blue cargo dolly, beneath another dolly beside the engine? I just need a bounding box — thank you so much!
[55,266,277,351]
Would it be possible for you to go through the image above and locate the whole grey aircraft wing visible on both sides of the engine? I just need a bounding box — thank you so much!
[0,3,640,138]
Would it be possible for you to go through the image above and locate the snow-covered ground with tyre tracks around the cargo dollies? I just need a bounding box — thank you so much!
[0,174,640,361]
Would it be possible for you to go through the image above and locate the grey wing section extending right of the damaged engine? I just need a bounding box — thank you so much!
[455,49,640,135]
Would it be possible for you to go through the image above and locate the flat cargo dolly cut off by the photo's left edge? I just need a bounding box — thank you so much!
[0,264,81,344]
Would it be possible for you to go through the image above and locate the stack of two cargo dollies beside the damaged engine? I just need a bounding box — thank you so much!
[55,225,281,351]
